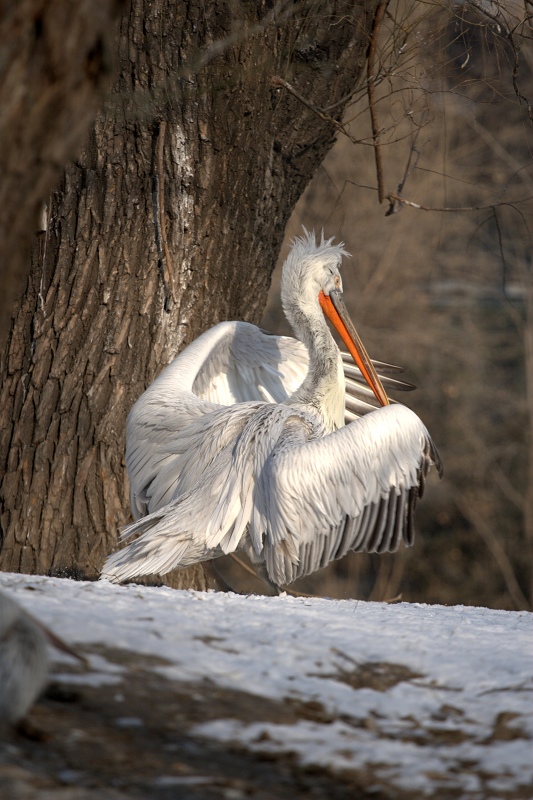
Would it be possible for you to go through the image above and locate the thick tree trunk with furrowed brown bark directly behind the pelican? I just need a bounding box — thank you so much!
[0,0,375,587]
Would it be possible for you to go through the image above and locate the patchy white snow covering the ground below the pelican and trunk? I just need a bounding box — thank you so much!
[0,573,533,798]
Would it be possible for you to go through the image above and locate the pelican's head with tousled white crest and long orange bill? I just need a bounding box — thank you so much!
[281,228,389,406]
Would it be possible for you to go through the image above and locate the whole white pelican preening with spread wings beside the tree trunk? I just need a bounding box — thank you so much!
[102,229,441,586]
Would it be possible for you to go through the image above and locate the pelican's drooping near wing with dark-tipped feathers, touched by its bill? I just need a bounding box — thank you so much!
[250,405,441,585]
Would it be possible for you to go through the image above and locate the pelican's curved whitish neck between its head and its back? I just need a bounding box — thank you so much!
[284,299,345,433]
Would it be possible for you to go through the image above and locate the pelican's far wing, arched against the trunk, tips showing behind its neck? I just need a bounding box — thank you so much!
[126,322,409,519]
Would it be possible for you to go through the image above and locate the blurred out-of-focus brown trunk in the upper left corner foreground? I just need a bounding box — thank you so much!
[0,0,124,335]
